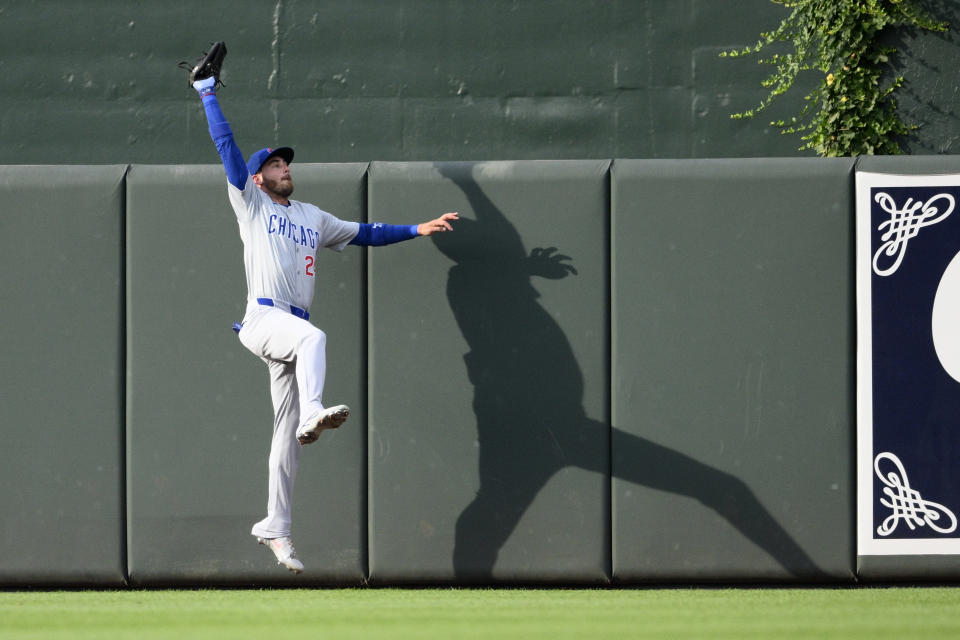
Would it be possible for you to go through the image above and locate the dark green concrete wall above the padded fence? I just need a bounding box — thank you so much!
[9,0,960,164]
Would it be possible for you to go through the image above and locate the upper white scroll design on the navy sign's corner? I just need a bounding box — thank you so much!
[873,191,954,276]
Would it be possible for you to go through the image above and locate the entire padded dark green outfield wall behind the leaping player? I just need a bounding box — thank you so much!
[0,157,956,587]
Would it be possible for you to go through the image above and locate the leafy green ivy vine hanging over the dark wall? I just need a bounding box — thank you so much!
[720,0,947,156]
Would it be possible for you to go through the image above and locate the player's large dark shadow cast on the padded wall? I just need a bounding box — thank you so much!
[432,163,825,583]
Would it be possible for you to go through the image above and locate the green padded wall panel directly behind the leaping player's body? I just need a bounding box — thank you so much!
[127,163,366,585]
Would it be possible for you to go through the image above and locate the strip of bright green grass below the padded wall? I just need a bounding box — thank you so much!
[0,587,960,640]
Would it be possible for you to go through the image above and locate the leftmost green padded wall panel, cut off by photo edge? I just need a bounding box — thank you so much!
[0,166,126,586]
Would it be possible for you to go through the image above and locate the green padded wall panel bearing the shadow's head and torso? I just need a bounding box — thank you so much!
[369,161,610,583]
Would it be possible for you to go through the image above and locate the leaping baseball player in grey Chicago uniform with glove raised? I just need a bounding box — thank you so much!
[187,42,458,573]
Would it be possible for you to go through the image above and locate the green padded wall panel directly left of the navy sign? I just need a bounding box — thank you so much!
[611,159,855,582]
